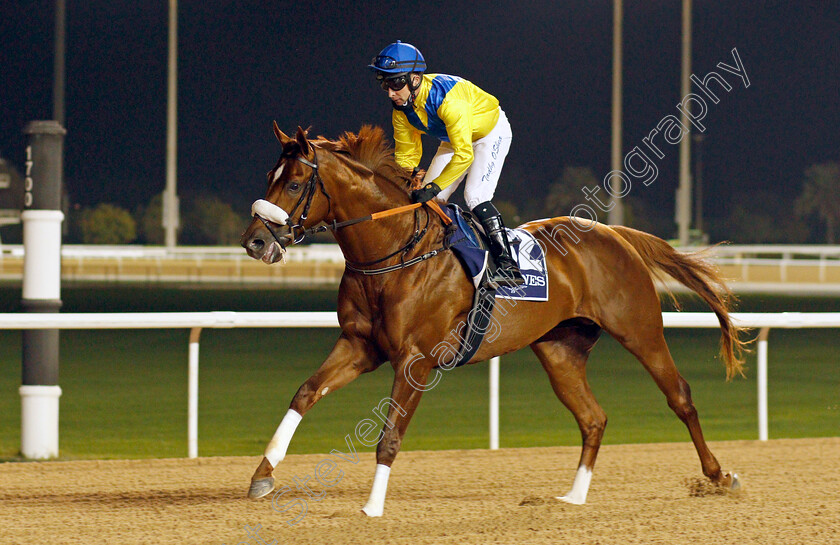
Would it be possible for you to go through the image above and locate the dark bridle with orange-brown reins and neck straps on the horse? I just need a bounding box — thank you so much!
[254,147,451,276]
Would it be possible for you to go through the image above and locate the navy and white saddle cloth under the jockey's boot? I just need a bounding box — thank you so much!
[444,204,548,301]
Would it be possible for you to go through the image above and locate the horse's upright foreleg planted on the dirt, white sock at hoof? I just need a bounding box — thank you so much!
[362,365,429,517]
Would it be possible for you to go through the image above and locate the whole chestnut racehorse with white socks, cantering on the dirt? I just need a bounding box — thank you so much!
[241,124,743,517]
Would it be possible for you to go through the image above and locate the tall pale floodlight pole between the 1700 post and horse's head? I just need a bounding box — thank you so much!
[162,0,179,249]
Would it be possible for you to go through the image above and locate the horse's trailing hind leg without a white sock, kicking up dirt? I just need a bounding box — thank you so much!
[615,320,738,488]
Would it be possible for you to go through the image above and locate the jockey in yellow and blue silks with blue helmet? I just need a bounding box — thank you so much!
[368,41,525,287]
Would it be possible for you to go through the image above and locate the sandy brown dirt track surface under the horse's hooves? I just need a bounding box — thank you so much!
[0,438,840,545]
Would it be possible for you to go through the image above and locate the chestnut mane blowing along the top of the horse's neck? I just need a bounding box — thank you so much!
[315,125,411,189]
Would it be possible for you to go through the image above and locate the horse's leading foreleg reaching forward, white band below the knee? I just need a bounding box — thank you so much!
[248,335,378,498]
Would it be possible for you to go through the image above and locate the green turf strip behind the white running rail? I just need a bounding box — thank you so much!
[0,287,840,458]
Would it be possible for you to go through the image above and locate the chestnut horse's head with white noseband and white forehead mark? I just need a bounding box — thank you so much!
[240,122,330,264]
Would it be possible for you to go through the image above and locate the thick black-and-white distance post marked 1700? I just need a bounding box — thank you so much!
[19,121,67,459]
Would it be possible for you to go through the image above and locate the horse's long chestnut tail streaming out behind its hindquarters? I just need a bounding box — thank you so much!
[611,225,746,380]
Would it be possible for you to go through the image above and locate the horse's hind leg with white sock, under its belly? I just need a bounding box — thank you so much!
[531,323,607,505]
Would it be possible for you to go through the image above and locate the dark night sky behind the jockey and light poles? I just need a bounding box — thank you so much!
[0,0,840,236]
